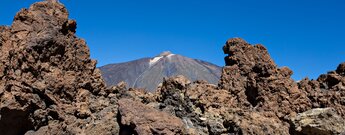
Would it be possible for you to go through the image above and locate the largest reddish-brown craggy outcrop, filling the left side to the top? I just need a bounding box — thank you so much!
[0,0,115,135]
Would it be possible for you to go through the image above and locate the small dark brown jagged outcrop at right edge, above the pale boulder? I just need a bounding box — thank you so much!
[299,63,345,118]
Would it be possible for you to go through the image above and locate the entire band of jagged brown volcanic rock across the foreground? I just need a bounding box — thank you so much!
[0,0,345,135]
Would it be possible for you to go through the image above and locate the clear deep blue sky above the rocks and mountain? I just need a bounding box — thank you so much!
[0,0,345,80]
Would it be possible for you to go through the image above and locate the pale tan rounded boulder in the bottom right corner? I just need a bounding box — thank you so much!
[292,108,345,135]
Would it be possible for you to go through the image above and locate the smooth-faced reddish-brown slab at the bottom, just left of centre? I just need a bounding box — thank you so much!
[118,99,186,135]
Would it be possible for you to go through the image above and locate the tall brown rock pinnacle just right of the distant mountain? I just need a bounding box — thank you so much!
[219,38,311,118]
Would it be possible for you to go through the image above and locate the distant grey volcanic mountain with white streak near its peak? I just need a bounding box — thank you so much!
[100,51,221,92]
